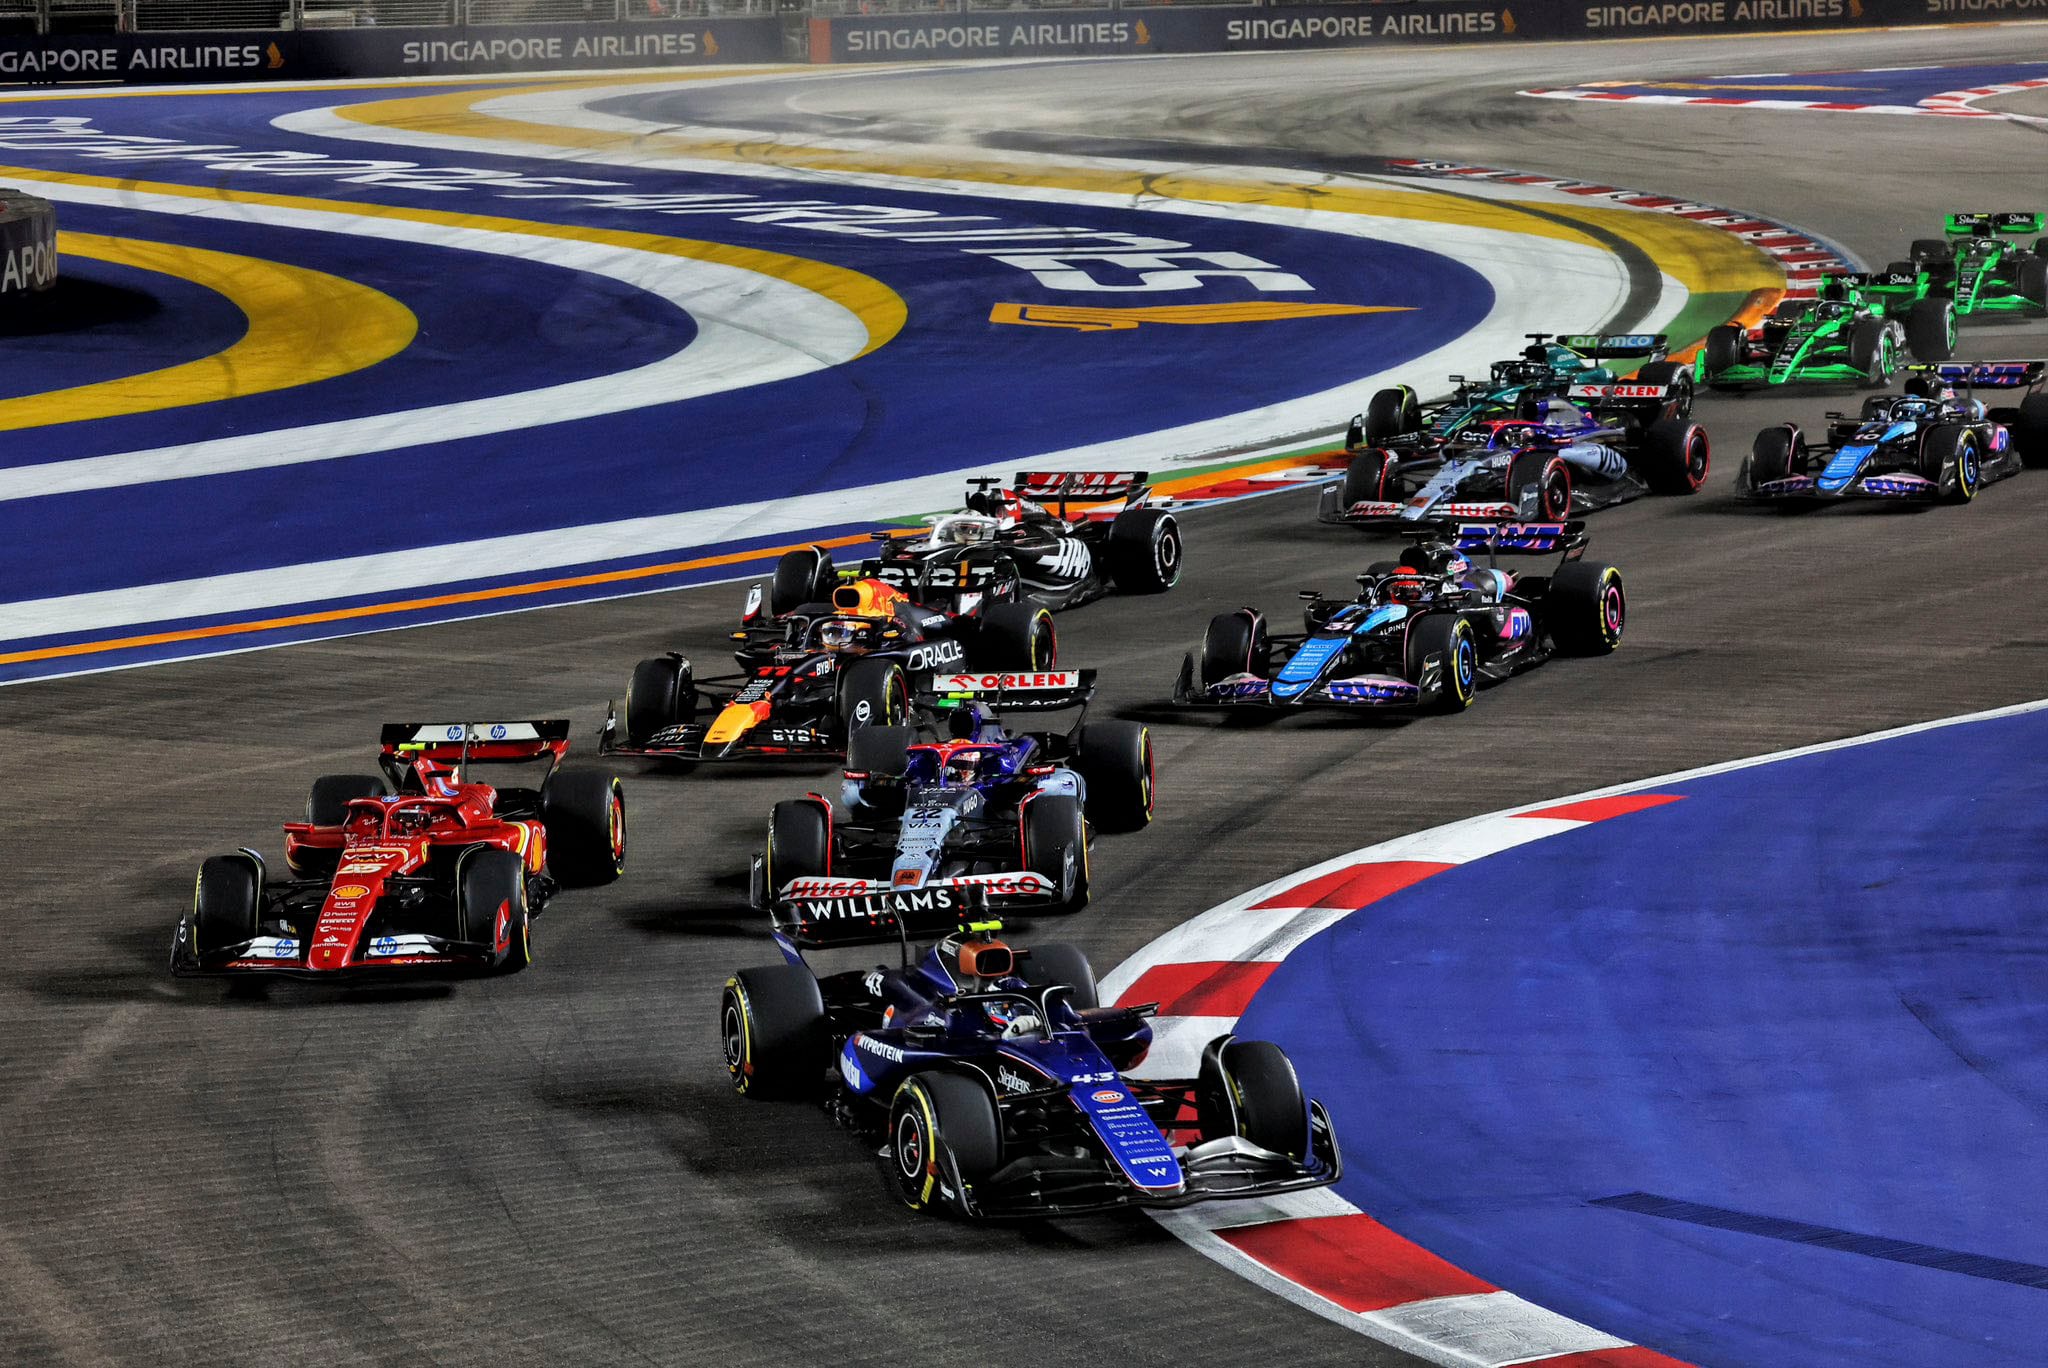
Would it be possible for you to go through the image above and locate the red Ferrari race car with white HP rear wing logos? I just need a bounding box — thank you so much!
[170,721,627,979]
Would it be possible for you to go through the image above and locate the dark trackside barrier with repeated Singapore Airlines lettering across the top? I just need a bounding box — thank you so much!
[0,0,2048,84]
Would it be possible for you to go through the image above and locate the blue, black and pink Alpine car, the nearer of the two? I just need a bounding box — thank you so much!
[1174,522,1628,713]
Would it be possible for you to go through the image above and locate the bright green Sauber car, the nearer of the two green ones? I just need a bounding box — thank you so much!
[1700,276,1908,389]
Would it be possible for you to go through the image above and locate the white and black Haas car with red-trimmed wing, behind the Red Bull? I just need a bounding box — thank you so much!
[772,471,1184,618]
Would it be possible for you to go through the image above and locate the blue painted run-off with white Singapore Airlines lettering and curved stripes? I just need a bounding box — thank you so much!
[0,88,1493,670]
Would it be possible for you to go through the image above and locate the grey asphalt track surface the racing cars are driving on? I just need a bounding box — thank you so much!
[0,27,2048,1364]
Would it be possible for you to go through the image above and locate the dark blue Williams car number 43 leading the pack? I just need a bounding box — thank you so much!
[719,901,1343,1219]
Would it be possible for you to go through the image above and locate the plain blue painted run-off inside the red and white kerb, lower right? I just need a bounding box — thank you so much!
[1239,711,2048,1368]
